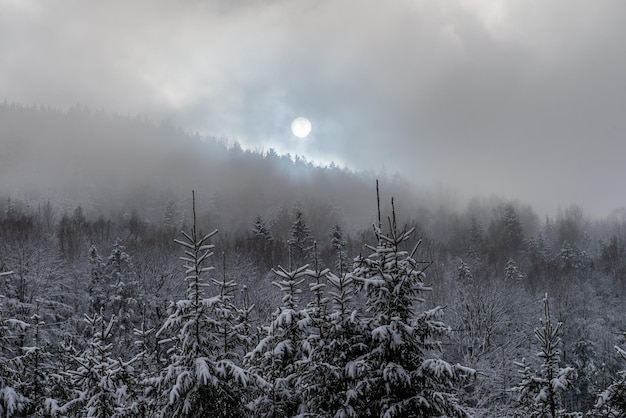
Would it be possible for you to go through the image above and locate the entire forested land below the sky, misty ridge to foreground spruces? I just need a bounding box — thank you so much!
[0,104,626,417]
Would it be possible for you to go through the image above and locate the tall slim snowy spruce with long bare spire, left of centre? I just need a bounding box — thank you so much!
[150,193,248,418]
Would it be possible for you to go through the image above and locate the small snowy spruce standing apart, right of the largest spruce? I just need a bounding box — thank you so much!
[512,294,578,418]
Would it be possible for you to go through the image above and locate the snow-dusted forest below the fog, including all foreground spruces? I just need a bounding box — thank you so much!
[0,192,626,417]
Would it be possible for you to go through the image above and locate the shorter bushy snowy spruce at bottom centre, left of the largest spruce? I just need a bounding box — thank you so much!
[246,265,311,418]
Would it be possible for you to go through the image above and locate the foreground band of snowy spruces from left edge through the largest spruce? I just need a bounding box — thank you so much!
[2,193,474,417]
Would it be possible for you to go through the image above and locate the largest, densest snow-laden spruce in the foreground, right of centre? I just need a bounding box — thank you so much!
[349,199,475,417]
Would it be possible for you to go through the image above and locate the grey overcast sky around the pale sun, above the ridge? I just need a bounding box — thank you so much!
[0,0,626,216]
